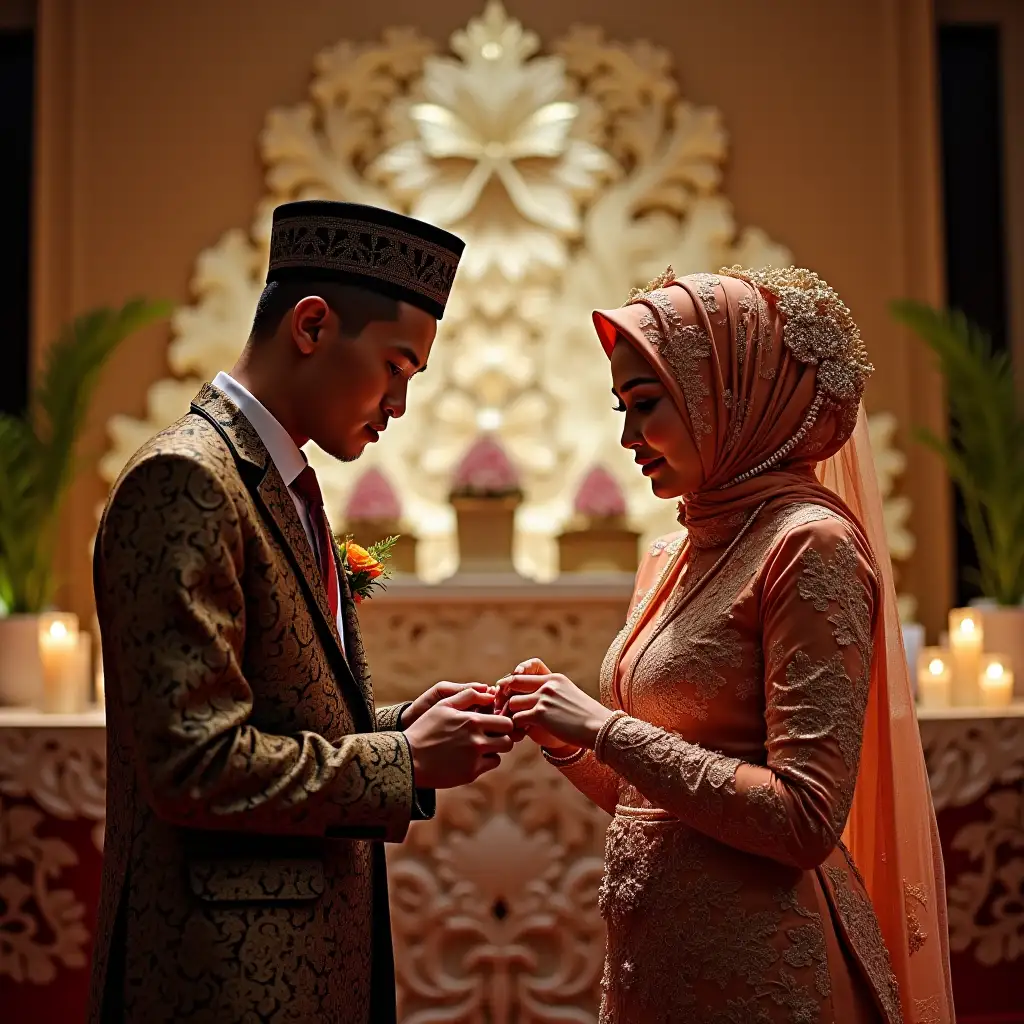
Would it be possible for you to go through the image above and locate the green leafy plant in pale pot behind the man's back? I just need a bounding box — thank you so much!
[0,299,170,705]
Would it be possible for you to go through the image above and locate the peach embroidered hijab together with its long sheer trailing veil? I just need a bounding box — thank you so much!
[594,267,954,1024]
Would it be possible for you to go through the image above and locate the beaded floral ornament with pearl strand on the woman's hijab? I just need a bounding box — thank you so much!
[625,266,874,489]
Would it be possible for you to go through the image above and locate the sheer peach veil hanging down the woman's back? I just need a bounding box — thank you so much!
[817,406,955,1024]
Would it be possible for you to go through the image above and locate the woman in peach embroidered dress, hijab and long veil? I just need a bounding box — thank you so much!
[499,268,953,1024]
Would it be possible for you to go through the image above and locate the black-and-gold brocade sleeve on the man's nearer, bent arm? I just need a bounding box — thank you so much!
[95,455,414,841]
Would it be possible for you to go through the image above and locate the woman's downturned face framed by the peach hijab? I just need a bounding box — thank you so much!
[611,338,703,498]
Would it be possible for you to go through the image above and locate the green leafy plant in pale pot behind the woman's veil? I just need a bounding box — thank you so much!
[892,301,1024,696]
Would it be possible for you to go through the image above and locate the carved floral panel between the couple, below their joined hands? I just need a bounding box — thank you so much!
[388,743,607,1024]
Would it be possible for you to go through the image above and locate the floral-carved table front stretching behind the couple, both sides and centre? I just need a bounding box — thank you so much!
[0,580,1024,1024]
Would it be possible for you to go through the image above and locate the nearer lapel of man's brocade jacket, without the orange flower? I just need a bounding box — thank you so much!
[191,384,374,729]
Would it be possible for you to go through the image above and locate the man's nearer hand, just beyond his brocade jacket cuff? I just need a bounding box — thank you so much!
[404,686,512,790]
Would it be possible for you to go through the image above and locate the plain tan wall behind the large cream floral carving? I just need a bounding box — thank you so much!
[36,0,950,629]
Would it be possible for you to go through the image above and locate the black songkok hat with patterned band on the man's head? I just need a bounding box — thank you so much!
[266,200,466,319]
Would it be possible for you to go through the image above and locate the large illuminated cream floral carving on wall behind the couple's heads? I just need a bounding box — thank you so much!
[101,0,788,580]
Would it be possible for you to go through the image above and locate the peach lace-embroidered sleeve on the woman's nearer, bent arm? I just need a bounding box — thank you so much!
[602,518,878,868]
